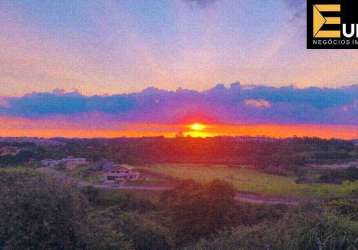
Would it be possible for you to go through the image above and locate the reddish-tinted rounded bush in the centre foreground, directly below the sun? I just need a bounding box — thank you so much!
[163,181,236,246]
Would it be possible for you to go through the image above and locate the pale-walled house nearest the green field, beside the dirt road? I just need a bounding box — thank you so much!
[104,164,140,183]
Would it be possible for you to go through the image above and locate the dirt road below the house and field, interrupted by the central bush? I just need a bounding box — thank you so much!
[37,167,300,205]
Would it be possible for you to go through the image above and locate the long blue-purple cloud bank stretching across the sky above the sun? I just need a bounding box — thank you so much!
[0,83,358,125]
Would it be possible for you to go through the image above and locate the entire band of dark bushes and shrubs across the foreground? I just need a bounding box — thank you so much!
[0,168,358,250]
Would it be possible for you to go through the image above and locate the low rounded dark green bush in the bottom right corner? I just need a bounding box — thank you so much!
[187,206,358,250]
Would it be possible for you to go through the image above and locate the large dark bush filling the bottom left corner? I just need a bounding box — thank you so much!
[0,169,133,250]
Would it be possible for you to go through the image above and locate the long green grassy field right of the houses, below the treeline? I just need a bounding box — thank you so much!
[144,164,358,198]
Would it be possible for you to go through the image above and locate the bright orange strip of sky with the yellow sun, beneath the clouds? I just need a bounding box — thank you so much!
[0,117,358,140]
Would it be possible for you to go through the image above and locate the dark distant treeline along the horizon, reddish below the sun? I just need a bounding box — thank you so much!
[0,137,358,171]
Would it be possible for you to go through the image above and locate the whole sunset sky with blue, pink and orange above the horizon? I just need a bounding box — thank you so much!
[0,0,358,138]
